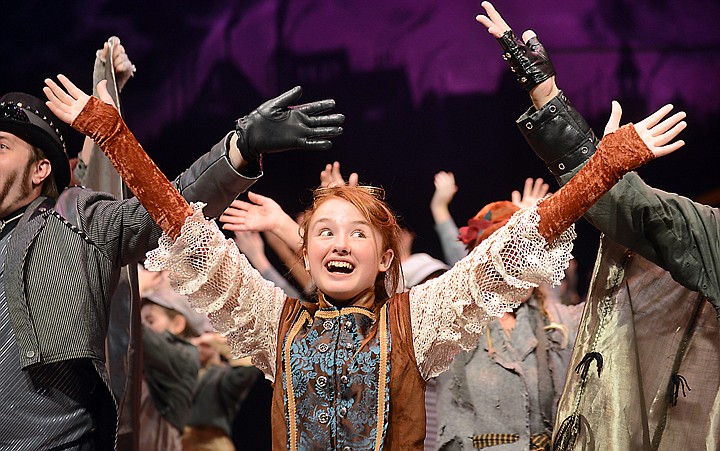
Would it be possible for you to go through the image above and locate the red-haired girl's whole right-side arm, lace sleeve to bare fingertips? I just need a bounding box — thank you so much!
[410,87,684,377]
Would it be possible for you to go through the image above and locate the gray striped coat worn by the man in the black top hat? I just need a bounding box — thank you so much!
[0,135,260,449]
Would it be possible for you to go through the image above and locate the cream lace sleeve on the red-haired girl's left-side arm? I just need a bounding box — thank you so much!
[145,203,287,381]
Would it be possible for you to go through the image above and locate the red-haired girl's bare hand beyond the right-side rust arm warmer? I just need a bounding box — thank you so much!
[603,100,687,157]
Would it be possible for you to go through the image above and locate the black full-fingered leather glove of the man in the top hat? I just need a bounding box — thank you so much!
[235,86,345,162]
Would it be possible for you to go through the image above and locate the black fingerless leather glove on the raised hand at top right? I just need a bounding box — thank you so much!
[497,30,555,92]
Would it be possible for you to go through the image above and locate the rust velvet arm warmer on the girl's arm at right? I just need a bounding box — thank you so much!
[538,124,655,243]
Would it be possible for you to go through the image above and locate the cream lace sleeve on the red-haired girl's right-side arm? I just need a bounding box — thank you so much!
[410,206,576,379]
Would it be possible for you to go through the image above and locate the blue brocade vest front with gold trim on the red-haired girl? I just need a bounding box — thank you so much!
[280,291,392,450]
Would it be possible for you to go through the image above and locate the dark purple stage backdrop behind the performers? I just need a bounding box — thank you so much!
[5,0,720,296]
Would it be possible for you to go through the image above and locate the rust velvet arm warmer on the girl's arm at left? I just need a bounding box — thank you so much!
[71,97,192,239]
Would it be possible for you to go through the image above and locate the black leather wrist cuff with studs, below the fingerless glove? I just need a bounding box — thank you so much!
[517,92,600,177]
